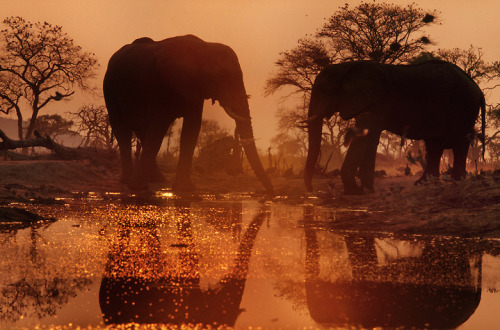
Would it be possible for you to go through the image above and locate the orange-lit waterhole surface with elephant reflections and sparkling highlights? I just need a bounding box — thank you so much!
[0,195,500,329]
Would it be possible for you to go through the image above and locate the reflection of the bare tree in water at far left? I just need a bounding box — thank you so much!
[0,220,92,322]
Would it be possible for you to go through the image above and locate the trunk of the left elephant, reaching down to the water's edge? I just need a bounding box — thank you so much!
[236,120,274,196]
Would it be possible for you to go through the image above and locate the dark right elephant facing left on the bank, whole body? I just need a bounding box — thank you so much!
[304,61,485,194]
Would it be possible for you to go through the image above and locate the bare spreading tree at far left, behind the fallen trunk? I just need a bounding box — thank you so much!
[0,17,98,140]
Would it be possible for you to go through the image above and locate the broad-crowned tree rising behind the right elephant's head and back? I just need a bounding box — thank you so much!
[265,3,437,170]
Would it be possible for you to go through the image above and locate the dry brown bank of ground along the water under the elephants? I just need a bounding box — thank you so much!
[0,161,500,238]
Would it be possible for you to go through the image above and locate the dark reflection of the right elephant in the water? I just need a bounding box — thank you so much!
[305,206,481,329]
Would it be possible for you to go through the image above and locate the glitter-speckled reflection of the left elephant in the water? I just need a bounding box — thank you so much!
[99,201,265,326]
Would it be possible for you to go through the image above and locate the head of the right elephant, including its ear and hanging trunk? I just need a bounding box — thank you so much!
[304,61,388,191]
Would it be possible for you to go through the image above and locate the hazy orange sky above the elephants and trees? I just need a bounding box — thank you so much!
[0,0,500,148]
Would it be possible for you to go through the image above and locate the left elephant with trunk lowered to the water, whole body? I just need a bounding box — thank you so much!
[103,35,273,193]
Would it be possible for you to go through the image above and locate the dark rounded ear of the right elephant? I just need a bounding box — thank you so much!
[338,62,388,120]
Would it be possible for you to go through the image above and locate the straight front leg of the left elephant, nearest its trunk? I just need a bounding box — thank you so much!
[172,101,203,191]
